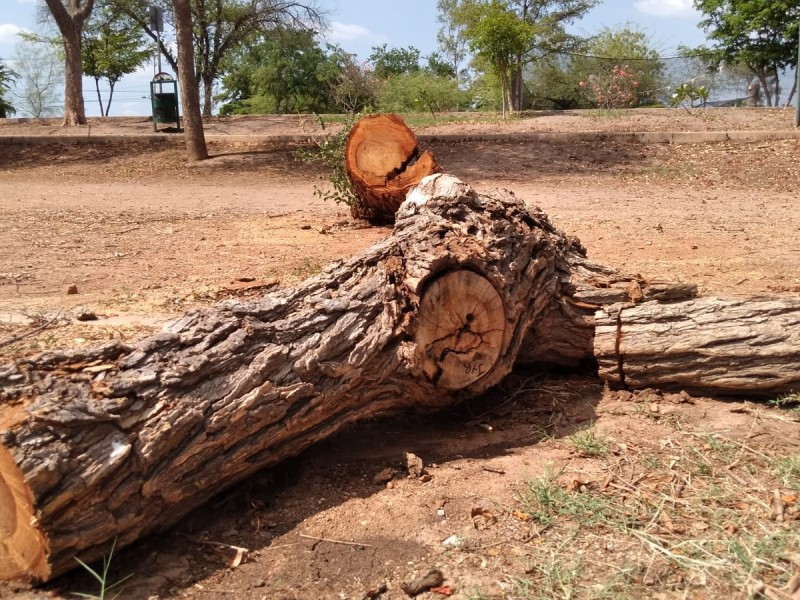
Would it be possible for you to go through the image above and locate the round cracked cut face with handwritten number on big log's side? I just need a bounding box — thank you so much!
[416,269,506,390]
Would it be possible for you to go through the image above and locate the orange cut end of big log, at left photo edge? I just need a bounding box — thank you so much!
[0,446,50,581]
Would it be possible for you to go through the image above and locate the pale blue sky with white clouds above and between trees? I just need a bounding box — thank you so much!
[0,0,705,115]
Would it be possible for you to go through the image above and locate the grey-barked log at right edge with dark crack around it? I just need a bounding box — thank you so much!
[594,297,800,395]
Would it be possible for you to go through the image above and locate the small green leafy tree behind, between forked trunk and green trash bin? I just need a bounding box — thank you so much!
[81,10,153,116]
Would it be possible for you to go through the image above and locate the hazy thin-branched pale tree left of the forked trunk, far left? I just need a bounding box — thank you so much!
[13,34,64,119]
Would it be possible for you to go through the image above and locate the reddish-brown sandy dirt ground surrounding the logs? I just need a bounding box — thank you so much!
[0,109,800,600]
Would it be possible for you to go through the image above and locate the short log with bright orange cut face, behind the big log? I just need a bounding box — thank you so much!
[345,114,441,225]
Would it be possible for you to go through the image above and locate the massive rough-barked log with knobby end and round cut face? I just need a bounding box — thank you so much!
[0,176,570,580]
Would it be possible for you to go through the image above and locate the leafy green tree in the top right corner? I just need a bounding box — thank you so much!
[694,0,800,106]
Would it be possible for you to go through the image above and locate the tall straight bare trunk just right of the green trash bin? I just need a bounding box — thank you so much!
[173,0,208,162]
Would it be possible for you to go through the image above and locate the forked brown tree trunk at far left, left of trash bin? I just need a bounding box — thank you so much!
[44,0,94,126]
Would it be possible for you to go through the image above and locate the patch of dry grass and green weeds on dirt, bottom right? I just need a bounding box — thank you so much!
[506,427,800,599]
